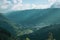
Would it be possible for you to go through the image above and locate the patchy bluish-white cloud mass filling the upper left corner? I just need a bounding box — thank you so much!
[0,0,22,11]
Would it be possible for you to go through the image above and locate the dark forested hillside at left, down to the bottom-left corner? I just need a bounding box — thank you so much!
[0,13,15,40]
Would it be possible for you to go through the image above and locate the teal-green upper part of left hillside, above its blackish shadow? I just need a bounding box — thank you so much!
[0,14,14,33]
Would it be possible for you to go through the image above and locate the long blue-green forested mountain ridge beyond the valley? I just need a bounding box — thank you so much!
[5,8,60,27]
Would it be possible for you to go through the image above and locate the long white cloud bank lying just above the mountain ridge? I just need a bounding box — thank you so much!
[12,4,50,10]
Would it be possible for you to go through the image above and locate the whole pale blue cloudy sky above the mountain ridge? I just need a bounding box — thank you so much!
[0,0,56,12]
